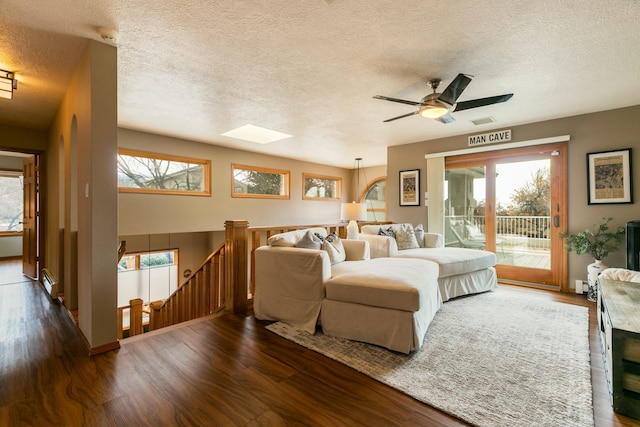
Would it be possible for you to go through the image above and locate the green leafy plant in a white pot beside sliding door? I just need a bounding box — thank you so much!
[560,217,625,301]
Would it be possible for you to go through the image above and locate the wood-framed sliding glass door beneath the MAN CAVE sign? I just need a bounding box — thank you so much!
[444,144,566,286]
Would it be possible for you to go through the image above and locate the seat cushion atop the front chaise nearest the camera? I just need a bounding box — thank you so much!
[325,258,438,311]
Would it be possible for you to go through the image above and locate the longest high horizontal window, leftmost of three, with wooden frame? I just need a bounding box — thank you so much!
[118,149,211,196]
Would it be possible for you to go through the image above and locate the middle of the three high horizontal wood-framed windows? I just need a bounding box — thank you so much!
[231,164,290,199]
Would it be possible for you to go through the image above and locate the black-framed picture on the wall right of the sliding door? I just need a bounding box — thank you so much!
[587,148,633,205]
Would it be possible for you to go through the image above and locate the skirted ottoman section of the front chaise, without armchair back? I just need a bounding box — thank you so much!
[320,258,442,353]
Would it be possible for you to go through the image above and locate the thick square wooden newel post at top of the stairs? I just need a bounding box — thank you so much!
[224,220,249,313]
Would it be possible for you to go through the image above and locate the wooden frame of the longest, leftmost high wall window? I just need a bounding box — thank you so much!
[118,148,211,197]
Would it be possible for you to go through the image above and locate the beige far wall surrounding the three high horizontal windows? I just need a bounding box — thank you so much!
[118,129,363,235]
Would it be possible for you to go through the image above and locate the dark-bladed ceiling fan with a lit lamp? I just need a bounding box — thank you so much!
[374,74,513,123]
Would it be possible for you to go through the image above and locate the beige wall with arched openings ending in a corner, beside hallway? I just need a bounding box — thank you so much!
[45,41,118,349]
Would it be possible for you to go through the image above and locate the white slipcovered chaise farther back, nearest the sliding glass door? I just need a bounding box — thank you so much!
[359,224,498,301]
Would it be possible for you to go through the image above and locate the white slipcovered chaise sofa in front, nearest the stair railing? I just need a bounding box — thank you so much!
[253,229,442,353]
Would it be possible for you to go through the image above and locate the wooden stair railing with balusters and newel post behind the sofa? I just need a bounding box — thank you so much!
[118,221,389,338]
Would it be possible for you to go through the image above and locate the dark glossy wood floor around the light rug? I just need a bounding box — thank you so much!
[0,262,640,427]
